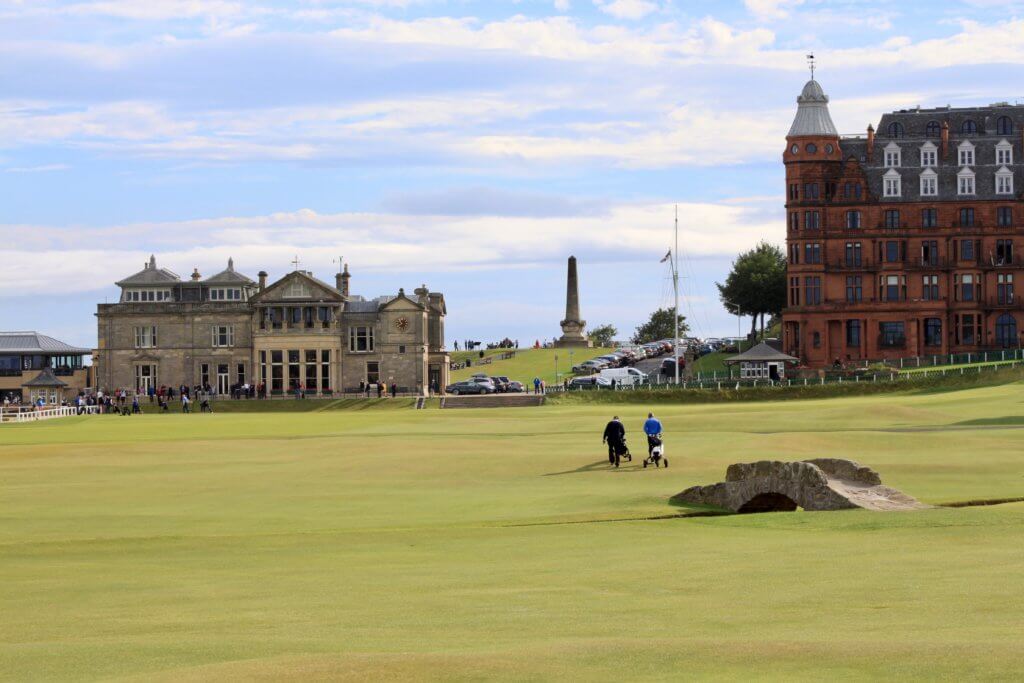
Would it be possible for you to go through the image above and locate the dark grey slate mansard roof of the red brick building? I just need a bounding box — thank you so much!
[840,104,1024,203]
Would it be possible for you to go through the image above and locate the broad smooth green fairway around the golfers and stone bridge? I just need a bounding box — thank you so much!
[0,383,1024,681]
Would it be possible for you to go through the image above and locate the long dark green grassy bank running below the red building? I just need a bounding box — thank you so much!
[547,368,1024,404]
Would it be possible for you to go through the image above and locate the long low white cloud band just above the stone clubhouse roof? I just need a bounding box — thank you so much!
[0,203,781,296]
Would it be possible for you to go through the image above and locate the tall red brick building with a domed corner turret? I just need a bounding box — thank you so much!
[782,79,1024,367]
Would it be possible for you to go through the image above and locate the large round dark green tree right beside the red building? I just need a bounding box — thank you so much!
[716,242,785,337]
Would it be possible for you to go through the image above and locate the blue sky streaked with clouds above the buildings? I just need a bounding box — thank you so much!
[0,0,1024,347]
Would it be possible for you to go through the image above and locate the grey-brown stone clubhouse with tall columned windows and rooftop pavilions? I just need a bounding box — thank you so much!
[93,257,449,396]
